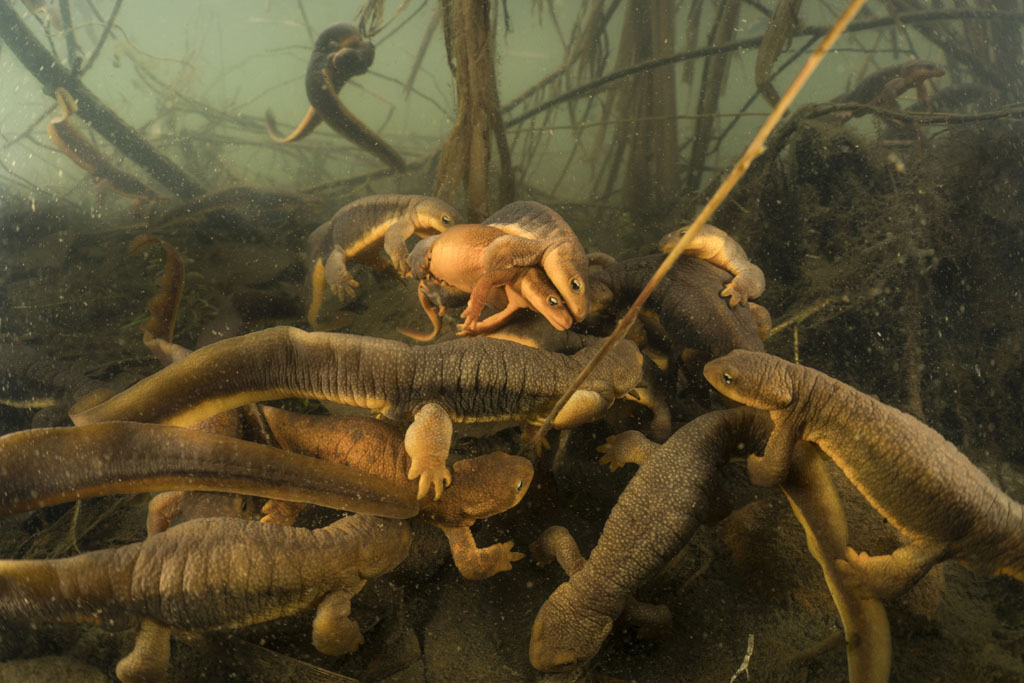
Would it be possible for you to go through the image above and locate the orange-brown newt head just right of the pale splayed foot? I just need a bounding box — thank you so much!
[452,452,534,519]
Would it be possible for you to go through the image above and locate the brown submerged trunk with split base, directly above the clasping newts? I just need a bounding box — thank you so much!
[434,0,514,220]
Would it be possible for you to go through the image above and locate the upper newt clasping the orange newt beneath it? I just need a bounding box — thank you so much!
[469,202,590,323]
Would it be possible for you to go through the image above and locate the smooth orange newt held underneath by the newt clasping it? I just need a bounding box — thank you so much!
[409,223,572,335]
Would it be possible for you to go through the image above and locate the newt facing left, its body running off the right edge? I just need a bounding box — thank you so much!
[705,350,1024,599]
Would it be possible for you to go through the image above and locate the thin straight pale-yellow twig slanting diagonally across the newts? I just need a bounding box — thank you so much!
[522,0,867,453]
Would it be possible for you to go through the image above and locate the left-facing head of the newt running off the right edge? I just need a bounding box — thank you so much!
[703,349,793,411]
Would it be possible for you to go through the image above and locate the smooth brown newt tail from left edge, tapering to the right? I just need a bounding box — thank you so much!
[0,421,419,517]
